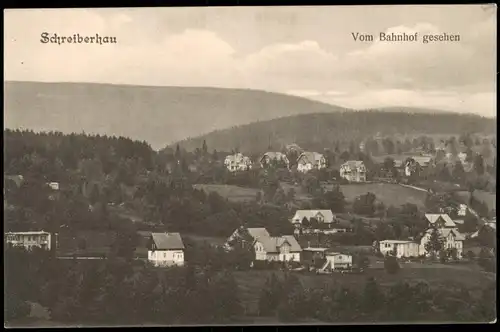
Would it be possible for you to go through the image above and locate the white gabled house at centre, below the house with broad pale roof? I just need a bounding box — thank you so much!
[254,235,302,262]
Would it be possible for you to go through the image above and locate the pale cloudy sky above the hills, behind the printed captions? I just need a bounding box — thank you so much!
[4,5,497,117]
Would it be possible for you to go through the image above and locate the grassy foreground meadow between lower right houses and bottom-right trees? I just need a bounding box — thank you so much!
[234,263,495,314]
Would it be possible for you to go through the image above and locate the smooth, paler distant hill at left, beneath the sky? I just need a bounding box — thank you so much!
[4,82,343,148]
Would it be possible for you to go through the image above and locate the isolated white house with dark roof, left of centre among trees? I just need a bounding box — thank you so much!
[148,233,185,266]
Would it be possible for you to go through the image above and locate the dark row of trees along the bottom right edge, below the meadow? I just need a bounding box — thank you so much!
[259,274,496,323]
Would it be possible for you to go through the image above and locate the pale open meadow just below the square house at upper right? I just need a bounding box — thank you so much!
[324,183,427,208]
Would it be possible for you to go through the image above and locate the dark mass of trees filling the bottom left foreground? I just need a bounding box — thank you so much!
[4,246,246,326]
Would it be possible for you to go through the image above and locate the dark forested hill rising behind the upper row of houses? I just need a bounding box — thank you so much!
[172,111,496,153]
